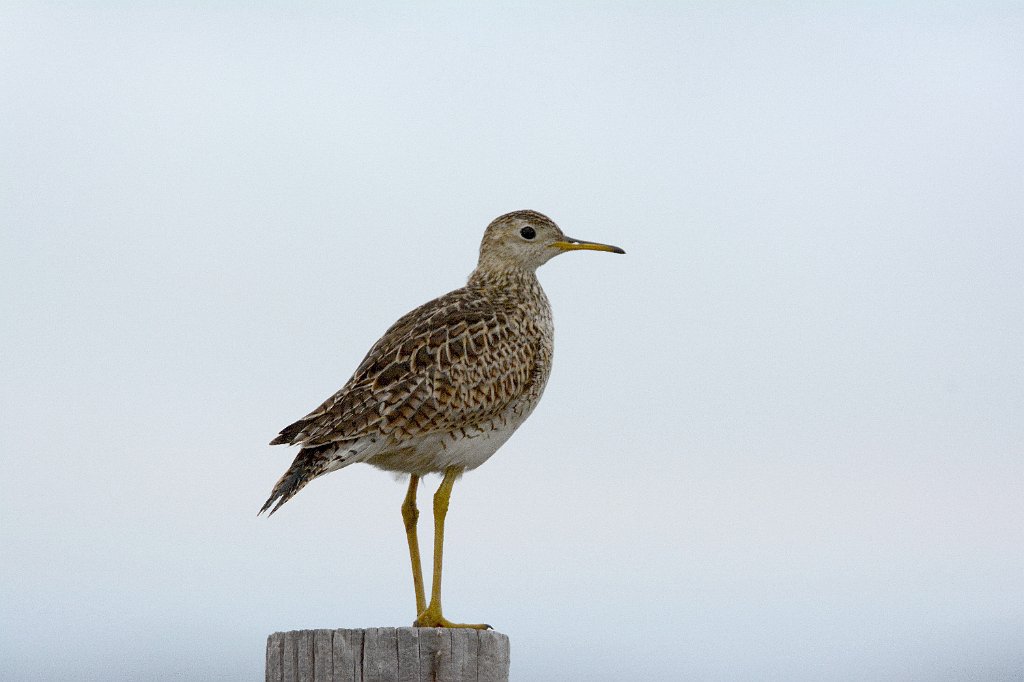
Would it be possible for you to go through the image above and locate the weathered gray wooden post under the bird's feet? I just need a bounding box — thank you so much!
[266,628,509,682]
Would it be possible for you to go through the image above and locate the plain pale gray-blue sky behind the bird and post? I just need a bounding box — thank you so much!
[0,2,1024,680]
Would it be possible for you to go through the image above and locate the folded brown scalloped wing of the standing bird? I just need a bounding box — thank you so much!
[271,289,550,446]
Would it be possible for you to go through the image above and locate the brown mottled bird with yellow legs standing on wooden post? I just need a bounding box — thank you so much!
[259,210,626,629]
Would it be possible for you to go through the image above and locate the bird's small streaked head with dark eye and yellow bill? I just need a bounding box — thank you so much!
[477,211,626,271]
